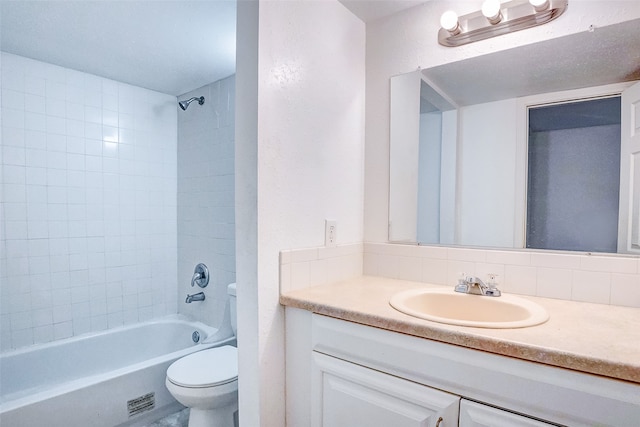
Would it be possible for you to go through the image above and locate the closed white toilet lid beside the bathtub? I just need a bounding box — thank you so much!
[167,345,238,387]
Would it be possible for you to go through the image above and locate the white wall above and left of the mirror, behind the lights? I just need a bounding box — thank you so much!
[365,0,640,242]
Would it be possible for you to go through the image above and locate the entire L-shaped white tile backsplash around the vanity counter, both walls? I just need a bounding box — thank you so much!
[280,243,640,308]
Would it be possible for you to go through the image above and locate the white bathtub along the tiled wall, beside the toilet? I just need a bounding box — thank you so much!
[0,316,235,427]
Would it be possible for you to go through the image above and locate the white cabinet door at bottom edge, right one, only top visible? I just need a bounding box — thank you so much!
[460,399,554,427]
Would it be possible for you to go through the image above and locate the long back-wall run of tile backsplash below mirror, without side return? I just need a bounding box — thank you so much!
[363,243,640,307]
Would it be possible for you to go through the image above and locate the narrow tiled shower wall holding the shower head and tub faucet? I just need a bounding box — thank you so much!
[177,76,236,326]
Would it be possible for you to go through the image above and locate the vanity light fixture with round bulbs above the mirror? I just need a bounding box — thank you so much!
[438,0,569,46]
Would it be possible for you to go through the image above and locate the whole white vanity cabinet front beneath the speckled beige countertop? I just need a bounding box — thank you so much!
[285,307,640,427]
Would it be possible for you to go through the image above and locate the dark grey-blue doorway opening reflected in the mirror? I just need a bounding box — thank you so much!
[526,96,621,252]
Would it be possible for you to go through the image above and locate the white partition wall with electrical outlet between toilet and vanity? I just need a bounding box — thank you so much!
[236,1,365,426]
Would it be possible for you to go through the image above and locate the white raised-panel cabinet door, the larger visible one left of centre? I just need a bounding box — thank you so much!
[311,352,460,427]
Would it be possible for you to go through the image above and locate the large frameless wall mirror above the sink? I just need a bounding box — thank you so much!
[389,20,640,254]
